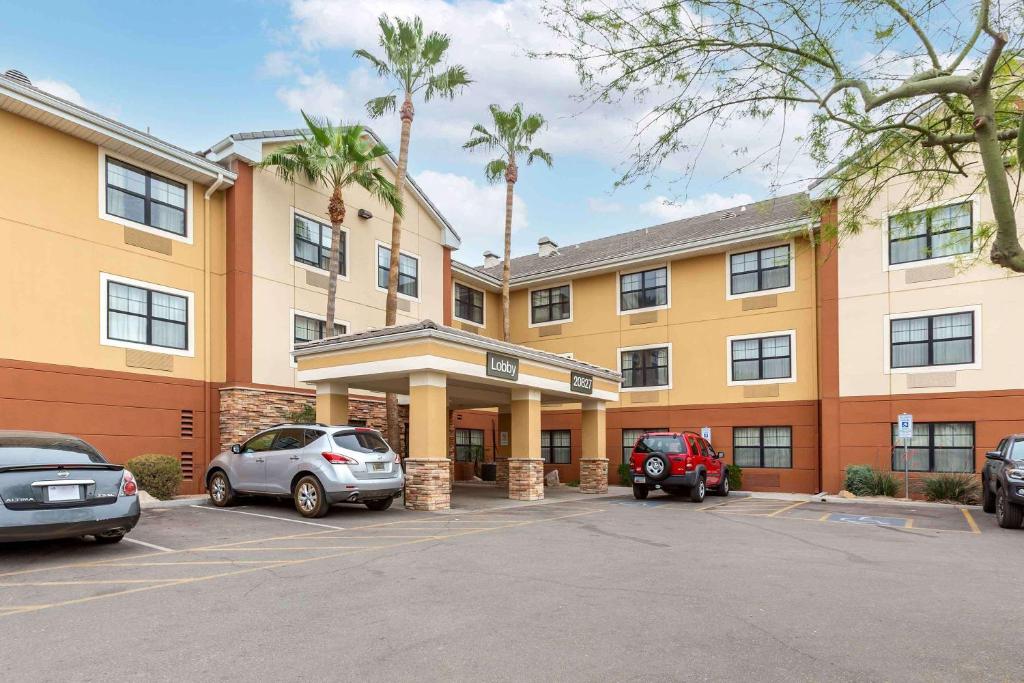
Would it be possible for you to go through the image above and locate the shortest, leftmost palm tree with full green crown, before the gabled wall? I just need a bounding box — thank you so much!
[256,112,402,337]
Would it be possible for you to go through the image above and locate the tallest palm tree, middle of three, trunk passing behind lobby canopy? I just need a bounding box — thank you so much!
[353,14,471,450]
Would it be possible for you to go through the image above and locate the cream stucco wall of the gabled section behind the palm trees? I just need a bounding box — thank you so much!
[253,143,443,386]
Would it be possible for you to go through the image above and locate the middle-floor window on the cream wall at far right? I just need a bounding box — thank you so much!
[890,311,974,368]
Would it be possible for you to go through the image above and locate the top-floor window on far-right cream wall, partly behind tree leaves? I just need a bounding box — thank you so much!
[889,202,974,265]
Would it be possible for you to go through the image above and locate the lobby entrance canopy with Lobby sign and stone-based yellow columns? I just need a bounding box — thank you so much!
[293,321,621,510]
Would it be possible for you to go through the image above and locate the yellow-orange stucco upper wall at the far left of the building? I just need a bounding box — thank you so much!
[0,112,224,381]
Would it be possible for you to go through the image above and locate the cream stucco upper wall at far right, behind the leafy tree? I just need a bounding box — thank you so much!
[838,178,1024,396]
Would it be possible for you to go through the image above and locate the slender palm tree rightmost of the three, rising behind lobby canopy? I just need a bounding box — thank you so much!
[462,102,551,341]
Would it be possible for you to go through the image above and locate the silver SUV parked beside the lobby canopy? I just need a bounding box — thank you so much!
[206,424,406,517]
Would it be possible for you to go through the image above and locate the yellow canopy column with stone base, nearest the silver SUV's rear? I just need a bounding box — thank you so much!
[406,371,452,510]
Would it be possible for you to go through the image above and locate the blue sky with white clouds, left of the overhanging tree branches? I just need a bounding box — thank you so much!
[0,0,831,264]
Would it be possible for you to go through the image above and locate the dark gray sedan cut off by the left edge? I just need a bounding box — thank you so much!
[0,430,139,543]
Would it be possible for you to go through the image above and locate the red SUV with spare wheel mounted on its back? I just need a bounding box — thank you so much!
[630,432,729,503]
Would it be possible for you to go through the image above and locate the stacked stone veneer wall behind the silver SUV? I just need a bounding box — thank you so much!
[220,387,409,454]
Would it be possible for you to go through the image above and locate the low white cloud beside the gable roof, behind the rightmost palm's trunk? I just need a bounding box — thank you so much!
[416,171,528,263]
